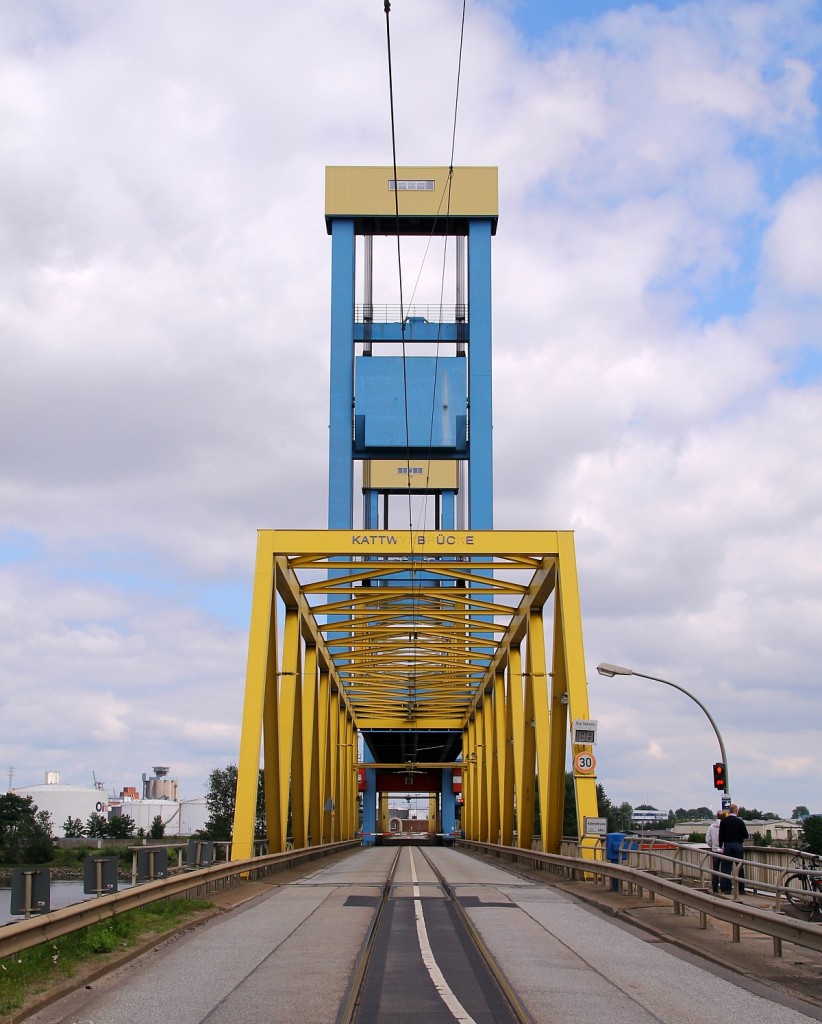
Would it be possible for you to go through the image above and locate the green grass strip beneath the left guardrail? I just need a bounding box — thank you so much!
[0,899,212,1019]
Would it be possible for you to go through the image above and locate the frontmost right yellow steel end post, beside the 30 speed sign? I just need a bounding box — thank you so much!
[551,530,599,856]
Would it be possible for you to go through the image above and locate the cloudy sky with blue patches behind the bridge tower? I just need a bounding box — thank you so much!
[0,0,822,814]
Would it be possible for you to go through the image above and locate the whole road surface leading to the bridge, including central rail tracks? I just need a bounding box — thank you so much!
[20,845,822,1024]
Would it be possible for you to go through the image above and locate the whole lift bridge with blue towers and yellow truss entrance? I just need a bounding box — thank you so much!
[231,167,597,859]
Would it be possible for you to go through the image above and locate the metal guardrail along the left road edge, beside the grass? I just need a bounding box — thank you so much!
[0,840,360,958]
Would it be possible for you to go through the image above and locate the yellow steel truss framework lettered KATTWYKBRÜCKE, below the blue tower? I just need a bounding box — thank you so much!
[231,530,597,859]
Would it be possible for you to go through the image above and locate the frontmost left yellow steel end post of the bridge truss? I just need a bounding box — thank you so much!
[231,530,277,860]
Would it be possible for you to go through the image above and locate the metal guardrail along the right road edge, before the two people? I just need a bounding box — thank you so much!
[455,840,822,956]
